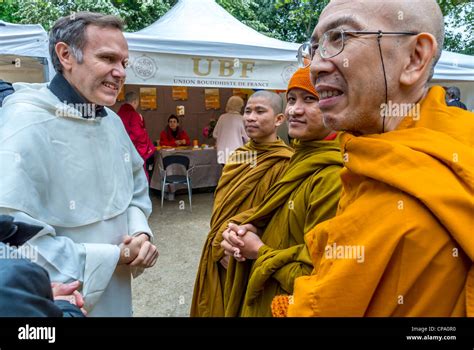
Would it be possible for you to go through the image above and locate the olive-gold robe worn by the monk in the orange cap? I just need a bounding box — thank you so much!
[221,140,342,317]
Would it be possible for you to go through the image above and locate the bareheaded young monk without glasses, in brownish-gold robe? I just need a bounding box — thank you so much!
[191,91,293,317]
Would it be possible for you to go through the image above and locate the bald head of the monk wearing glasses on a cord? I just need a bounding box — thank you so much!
[311,0,443,134]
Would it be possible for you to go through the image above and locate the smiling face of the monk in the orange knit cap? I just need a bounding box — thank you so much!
[285,88,330,141]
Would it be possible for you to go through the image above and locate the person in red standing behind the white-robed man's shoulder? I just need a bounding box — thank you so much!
[117,92,156,181]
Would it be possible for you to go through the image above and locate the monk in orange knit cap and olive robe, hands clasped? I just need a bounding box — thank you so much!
[222,68,342,317]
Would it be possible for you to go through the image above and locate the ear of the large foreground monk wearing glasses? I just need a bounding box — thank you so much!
[400,33,438,85]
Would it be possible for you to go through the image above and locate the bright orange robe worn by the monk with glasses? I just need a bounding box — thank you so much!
[288,86,474,317]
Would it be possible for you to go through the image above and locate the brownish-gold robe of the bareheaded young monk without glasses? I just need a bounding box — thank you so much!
[191,140,293,317]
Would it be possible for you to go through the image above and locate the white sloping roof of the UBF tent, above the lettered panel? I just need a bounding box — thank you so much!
[125,0,299,61]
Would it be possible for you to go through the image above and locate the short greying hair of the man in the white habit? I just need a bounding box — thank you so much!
[49,11,123,73]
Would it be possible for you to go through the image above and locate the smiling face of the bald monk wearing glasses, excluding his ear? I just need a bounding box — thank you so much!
[311,1,390,133]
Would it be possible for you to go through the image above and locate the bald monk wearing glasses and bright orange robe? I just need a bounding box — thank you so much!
[274,0,474,317]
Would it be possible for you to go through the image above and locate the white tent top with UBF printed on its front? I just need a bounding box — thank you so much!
[125,0,299,89]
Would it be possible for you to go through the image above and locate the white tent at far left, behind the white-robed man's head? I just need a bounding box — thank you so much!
[0,21,52,83]
